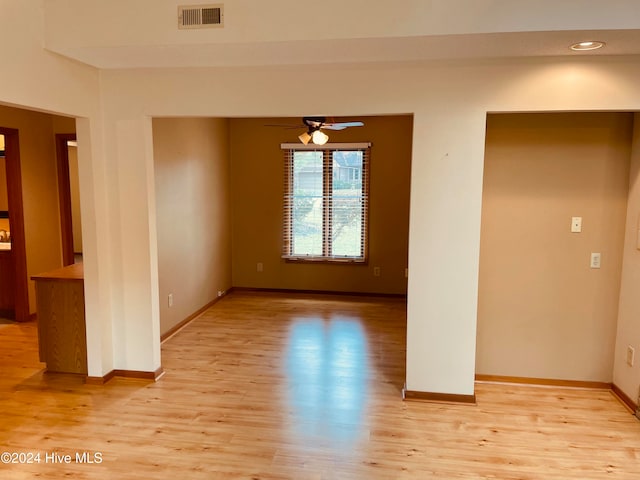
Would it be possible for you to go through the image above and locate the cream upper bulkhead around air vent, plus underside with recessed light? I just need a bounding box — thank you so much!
[43,0,640,69]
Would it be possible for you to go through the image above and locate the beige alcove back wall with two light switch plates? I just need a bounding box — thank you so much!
[476,113,633,382]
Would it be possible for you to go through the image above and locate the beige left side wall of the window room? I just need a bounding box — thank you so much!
[153,118,231,333]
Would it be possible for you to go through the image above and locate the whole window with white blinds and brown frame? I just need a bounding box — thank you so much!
[282,143,370,263]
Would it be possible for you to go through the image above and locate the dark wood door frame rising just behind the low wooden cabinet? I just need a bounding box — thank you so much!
[56,133,76,267]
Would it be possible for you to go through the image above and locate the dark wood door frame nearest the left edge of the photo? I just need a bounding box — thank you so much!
[0,127,30,322]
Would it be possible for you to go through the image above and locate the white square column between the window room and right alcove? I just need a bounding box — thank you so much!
[406,107,486,395]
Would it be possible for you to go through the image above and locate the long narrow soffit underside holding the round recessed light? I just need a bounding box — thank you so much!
[46,30,640,69]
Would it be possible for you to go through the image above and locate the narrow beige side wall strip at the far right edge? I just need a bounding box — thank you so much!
[613,113,640,401]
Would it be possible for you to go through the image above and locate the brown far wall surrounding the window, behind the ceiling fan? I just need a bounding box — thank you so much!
[230,116,413,294]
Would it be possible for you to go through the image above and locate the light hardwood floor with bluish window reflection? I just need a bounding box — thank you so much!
[0,292,640,480]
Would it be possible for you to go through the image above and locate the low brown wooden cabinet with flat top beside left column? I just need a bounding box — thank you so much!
[32,263,87,375]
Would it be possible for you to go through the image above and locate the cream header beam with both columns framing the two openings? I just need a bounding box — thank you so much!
[97,57,640,394]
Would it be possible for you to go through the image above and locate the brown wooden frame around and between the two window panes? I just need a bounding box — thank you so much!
[281,142,371,265]
